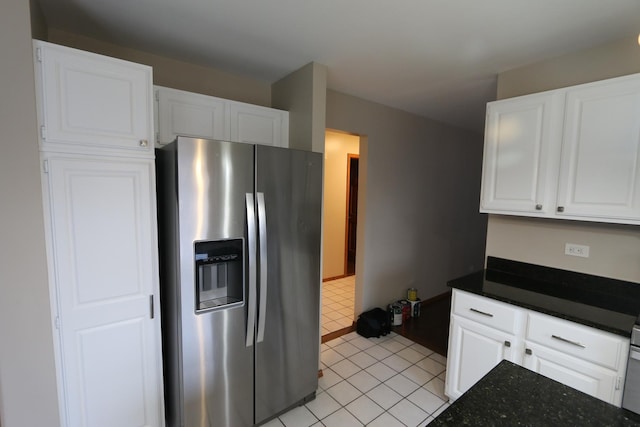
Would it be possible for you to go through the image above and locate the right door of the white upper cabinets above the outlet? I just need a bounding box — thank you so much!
[558,78,640,219]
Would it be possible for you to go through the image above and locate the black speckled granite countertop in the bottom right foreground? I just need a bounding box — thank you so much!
[429,360,640,427]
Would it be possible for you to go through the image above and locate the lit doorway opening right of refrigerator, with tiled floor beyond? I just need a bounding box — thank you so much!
[321,130,360,342]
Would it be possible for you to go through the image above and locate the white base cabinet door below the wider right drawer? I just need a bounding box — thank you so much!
[524,341,624,406]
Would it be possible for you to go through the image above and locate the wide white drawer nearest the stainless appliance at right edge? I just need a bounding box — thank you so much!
[525,313,629,370]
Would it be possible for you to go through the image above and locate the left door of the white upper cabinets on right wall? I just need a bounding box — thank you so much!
[481,93,560,214]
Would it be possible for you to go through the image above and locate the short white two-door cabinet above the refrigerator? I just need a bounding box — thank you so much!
[155,86,289,147]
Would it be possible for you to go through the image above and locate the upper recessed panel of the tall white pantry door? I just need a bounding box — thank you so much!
[64,171,142,306]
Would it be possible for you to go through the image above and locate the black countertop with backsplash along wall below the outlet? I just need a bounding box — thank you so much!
[448,257,640,337]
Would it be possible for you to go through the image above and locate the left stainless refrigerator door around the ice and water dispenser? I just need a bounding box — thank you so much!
[177,138,255,427]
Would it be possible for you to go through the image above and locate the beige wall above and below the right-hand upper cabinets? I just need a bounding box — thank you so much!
[486,37,640,282]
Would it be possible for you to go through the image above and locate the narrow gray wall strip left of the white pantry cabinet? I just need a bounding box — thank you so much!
[0,0,59,427]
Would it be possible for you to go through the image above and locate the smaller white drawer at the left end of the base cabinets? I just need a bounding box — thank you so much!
[451,289,524,334]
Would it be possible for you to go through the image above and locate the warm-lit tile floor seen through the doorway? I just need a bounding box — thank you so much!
[322,276,356,335]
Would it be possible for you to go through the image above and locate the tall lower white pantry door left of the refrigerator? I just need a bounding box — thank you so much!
[45,157,163,426]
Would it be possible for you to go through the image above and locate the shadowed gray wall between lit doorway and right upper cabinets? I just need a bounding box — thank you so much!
[327,91,486,313]
